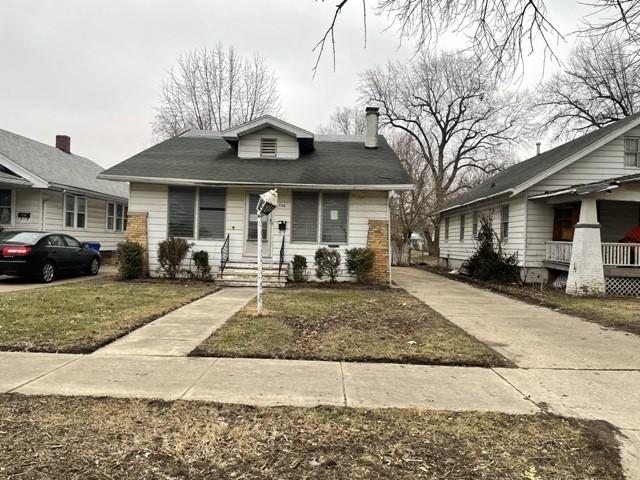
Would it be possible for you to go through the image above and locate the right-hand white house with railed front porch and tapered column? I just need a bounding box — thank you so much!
[439,114,640,295]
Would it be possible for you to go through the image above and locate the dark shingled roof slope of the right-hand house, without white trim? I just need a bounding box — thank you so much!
[442,113,640,210]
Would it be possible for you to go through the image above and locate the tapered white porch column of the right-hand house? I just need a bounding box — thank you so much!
[566,198,605,295]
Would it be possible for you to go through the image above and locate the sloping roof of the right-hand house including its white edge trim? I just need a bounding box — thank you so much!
[441,113,640,212]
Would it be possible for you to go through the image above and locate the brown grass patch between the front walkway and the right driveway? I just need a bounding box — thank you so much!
[192,287,511,366]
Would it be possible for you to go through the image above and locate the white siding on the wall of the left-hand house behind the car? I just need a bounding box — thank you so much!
[2,188,124,251]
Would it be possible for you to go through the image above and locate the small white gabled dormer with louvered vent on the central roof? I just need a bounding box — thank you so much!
[222,115,313,160]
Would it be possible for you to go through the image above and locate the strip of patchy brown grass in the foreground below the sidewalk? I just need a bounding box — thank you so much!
[0,395,624,480]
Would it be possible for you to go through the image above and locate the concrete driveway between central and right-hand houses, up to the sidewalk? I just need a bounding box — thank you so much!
[393,268,640,370]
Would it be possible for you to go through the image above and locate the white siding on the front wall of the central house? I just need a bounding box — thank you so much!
[129,183,388,279]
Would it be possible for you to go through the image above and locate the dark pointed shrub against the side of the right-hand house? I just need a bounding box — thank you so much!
[462,217,520,283]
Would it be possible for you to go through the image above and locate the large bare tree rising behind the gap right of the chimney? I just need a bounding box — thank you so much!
[360,54,525,253]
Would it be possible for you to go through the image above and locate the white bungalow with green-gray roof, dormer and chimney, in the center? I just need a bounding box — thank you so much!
[99,108,411,286]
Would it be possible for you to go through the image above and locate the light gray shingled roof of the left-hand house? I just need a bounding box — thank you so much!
[0,129,129,198]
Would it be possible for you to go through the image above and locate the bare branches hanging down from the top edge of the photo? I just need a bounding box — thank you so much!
[313,0,640,74]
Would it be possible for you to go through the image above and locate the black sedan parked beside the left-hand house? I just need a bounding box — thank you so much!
[0,232,100,283]
